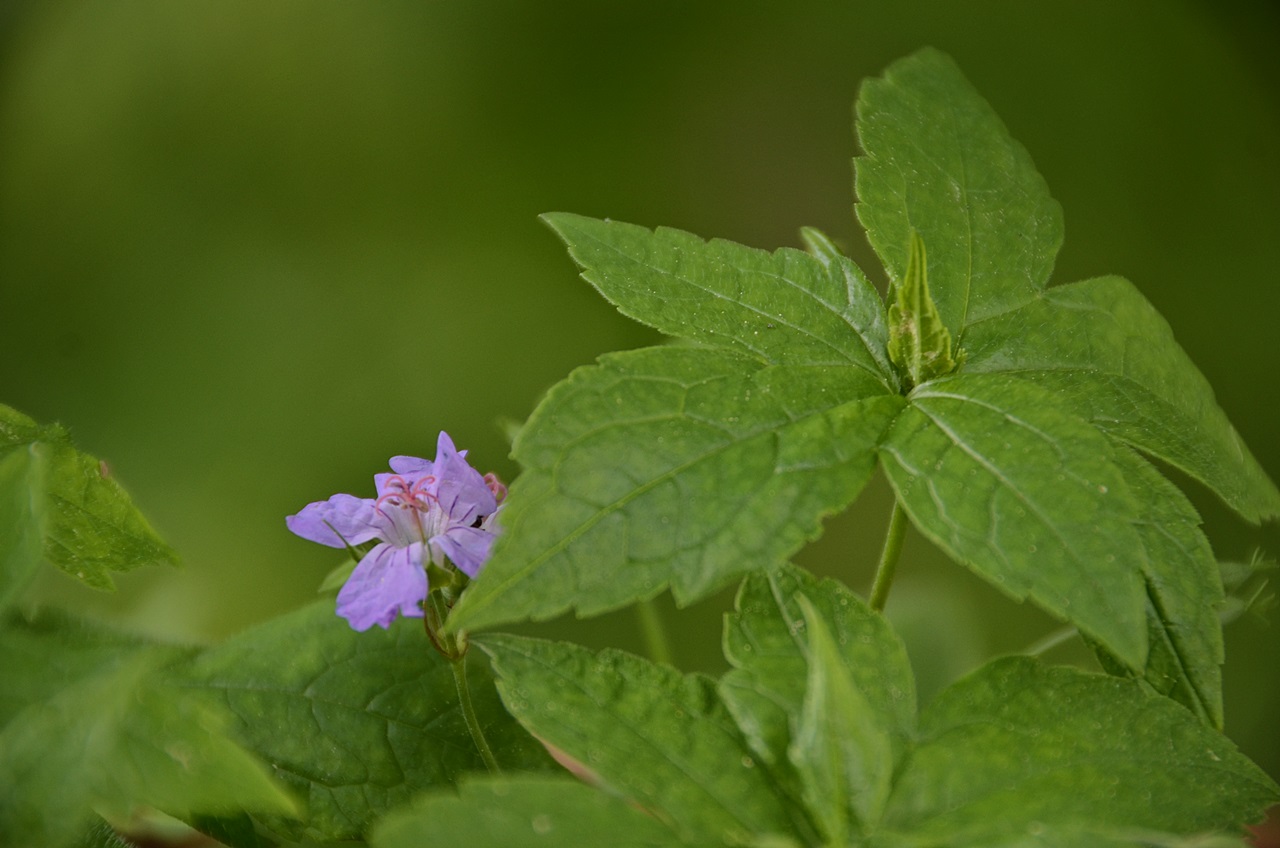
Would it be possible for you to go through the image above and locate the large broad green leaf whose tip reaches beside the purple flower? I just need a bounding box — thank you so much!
[451,347,902,629]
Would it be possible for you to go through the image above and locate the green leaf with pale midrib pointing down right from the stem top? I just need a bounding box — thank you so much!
[881,374,1147,670]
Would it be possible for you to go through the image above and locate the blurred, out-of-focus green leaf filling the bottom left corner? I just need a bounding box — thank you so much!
[0,619,296,845]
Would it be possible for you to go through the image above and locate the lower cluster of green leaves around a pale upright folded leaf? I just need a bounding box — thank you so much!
[445,567,1280,848]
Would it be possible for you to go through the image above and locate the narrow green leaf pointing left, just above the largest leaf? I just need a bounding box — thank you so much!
[543,213,895,389]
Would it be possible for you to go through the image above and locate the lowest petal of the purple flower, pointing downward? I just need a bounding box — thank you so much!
[338,542,426,630]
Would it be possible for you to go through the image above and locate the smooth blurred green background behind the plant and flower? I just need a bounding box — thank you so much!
[0,0,1280,775]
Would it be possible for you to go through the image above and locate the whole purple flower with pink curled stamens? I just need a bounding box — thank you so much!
[284,432,506,630]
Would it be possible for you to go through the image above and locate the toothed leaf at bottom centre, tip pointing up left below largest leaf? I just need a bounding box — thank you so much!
[475,634,795,844]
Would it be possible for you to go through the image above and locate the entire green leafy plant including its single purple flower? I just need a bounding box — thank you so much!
[0,50,1280,848]
